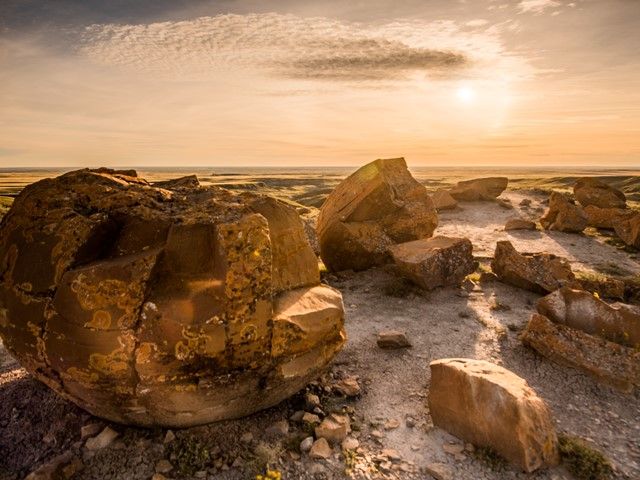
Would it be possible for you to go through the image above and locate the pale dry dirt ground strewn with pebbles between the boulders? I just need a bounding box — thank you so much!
[0,183,640,480]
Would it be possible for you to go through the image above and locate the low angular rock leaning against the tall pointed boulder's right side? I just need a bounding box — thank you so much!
[389,236,477,290]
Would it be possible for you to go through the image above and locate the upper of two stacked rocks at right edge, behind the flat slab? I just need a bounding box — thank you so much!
[537,287,640,348]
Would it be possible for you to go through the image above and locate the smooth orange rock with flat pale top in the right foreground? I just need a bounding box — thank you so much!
[429,359,558,472]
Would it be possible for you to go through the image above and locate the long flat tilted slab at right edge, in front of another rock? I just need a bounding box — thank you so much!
[521,313,640,392]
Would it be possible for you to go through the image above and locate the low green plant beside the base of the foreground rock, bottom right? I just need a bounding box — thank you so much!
[558,435,613,480]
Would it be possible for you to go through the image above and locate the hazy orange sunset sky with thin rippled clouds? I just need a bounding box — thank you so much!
[0,0,640,167]
